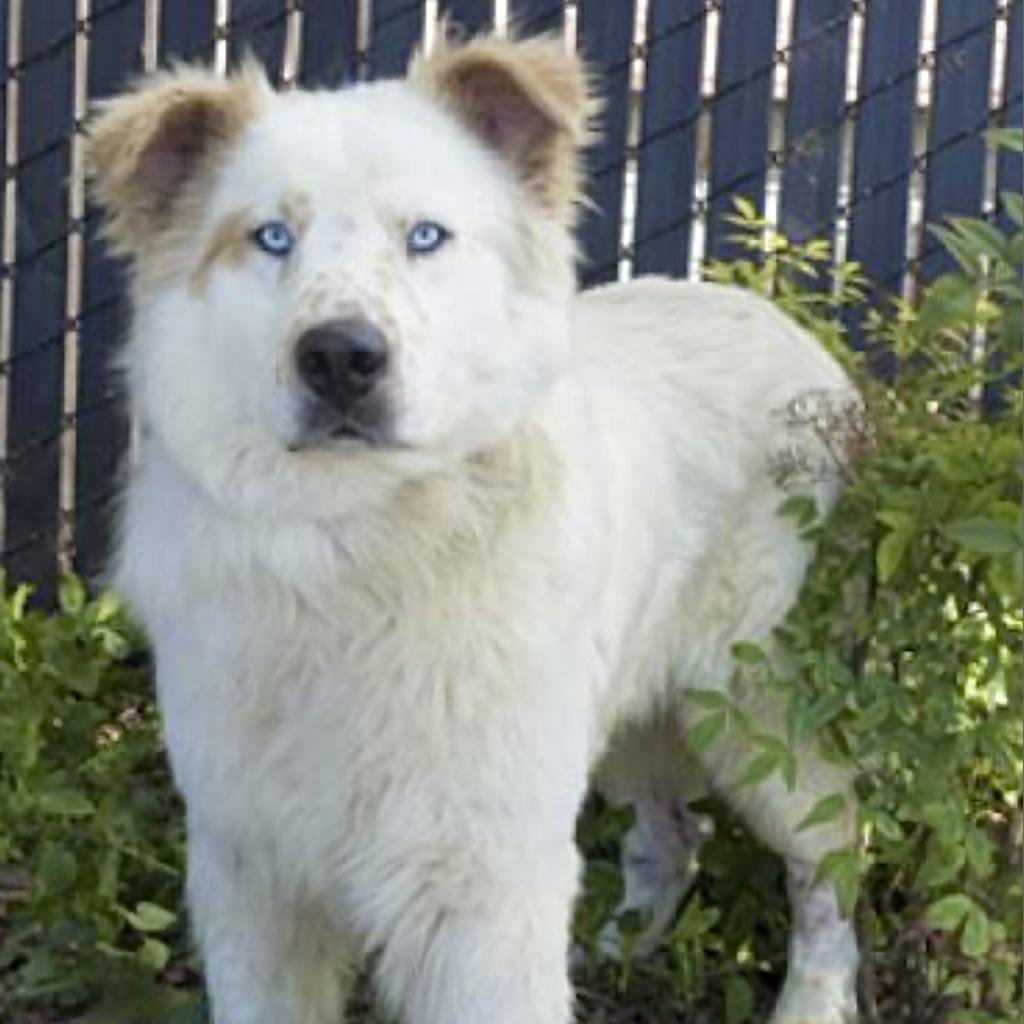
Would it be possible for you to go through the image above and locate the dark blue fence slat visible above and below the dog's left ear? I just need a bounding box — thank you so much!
[75,0,146,577]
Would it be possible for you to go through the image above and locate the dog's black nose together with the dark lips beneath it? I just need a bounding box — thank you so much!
[295,319,391,446]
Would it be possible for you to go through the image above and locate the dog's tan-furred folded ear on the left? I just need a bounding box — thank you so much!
[86,63,269,255]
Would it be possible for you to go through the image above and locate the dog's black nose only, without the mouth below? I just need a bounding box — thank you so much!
[295,319,387,410]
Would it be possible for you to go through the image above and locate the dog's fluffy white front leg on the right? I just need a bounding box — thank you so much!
[377,839,579,1024]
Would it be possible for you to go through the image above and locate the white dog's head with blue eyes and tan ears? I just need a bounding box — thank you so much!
[89,39,589,514]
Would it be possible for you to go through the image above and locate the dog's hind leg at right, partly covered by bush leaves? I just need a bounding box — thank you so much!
[688,679,858,1024]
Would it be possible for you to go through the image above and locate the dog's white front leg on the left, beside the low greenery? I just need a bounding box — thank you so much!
[188,823,353,1024]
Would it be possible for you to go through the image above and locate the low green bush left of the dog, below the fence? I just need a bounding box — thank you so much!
[0,580,203,1024]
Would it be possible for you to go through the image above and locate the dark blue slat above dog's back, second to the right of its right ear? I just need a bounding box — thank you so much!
[633,0,707,276]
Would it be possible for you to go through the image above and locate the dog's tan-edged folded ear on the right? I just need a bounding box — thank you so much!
[410,38,596,221]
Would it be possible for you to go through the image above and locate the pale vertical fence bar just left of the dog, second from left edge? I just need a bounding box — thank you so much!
[56,0,92,573]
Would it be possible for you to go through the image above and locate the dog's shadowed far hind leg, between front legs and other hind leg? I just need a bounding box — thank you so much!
[595,716,711,957]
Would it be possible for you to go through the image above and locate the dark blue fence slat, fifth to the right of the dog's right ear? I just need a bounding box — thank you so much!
[849,0,921,303]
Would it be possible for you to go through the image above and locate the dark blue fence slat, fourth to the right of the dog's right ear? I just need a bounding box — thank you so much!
[779,0,853,242]
